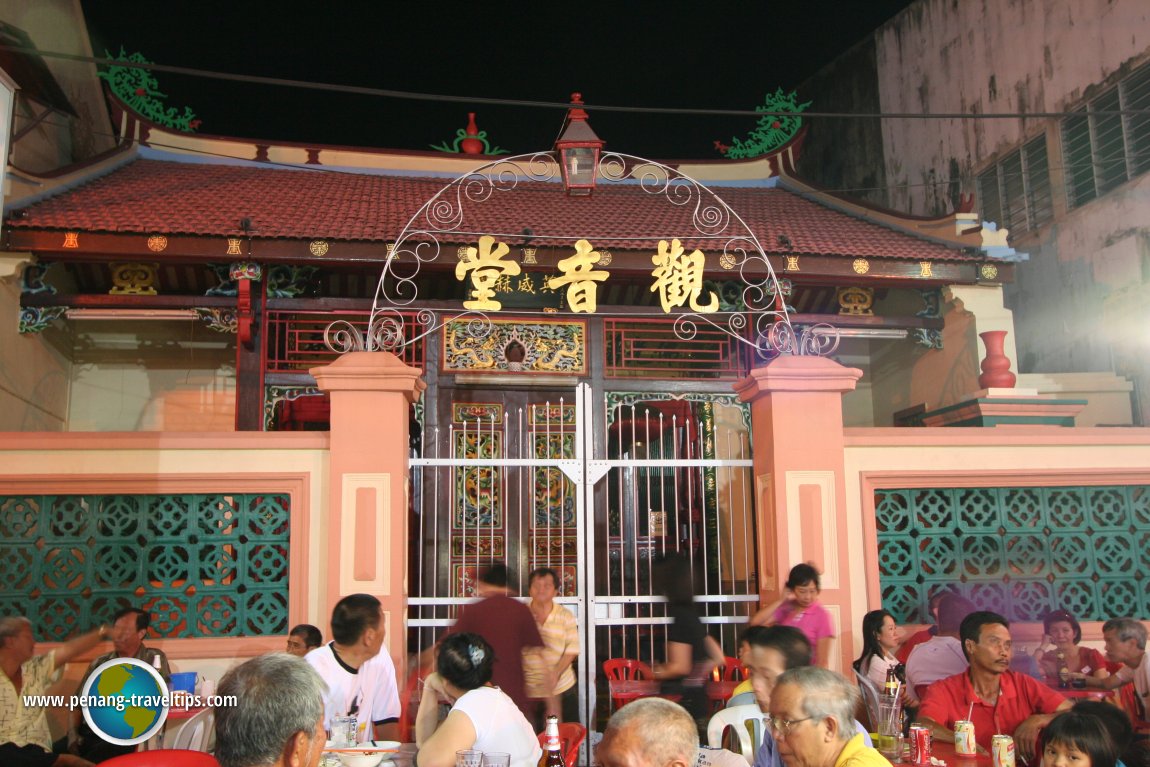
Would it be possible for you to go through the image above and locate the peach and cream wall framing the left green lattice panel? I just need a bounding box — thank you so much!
[0,432,333,735]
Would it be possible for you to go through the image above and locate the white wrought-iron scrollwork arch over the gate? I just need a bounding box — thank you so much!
[324,152,838,359]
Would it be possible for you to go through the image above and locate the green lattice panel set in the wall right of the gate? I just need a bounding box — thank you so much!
[875,485,1150,622]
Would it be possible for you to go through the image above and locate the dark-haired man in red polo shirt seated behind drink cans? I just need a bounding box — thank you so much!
[918,611,1071,765]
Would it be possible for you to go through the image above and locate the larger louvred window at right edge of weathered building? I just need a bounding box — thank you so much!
[1061,64,1150,208]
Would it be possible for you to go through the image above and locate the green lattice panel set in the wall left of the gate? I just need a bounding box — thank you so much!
[0,493,291,641]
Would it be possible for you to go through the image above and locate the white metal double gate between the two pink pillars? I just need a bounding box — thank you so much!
[408,383,759,727]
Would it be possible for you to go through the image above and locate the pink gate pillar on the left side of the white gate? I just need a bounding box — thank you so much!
[311,352,427,669]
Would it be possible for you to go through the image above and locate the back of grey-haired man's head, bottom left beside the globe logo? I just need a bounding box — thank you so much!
[215,652,328,767]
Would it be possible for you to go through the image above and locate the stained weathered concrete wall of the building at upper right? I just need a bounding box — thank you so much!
[800,0,1150,423]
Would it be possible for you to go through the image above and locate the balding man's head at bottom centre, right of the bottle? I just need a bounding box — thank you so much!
[596,698,694,767]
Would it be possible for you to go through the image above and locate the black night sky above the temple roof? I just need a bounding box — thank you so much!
[82,0,909,160]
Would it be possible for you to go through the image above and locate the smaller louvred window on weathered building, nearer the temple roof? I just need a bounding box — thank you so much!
[979,136,1053,231]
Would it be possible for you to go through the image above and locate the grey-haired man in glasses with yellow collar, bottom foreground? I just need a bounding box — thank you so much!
[766,666,890,767]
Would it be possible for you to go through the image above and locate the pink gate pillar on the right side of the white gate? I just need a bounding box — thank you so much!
[735,355,865,670]
